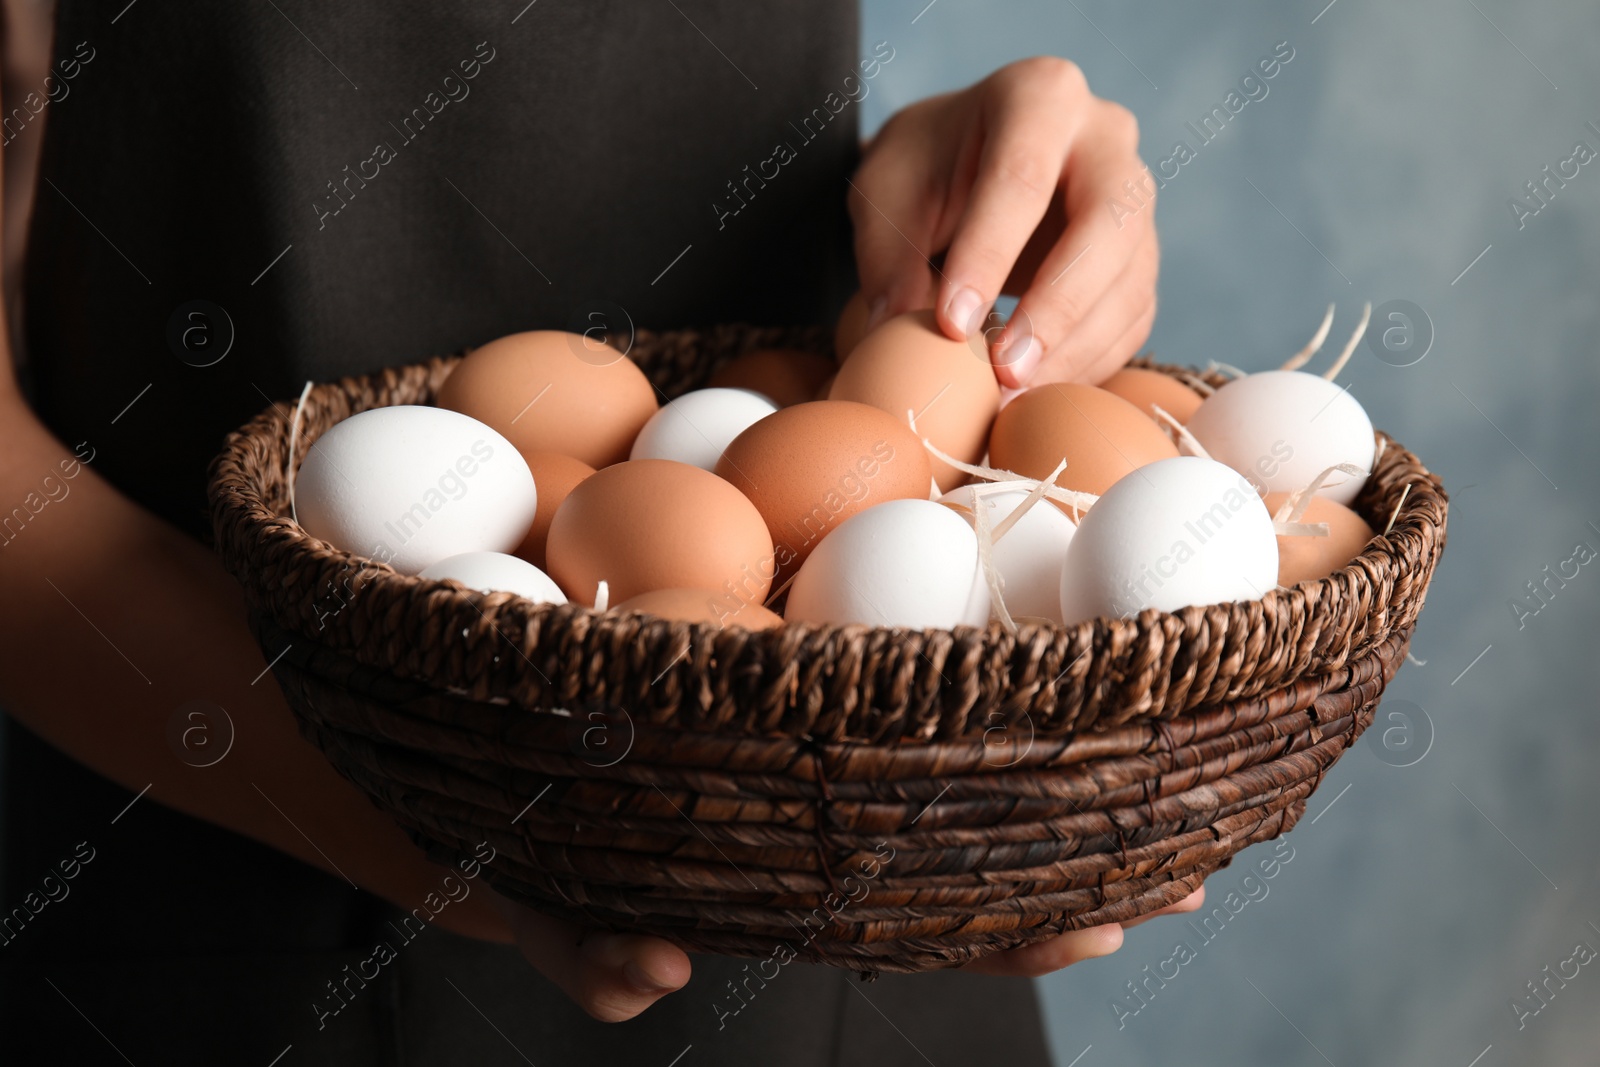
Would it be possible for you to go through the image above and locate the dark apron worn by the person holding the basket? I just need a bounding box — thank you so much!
[0,0,1046,1067]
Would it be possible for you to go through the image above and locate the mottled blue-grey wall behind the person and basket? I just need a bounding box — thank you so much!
[864,0,1600,1067]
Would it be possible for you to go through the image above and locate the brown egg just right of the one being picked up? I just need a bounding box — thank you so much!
[989,382,1178,494]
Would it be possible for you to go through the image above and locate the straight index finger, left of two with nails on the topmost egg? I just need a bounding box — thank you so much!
[936,58,1090,338]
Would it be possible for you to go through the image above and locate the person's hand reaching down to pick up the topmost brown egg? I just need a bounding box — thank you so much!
[850,56,1160,387]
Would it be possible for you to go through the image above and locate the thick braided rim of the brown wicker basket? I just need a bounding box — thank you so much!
[210,330,1448,739]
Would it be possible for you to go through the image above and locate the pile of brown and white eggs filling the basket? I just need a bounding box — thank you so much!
[291,301,1376,629]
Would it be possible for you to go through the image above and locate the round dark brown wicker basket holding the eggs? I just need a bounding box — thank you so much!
[211,326,1446,973]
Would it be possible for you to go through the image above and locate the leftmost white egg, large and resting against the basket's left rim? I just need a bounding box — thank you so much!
[294,405,538,574]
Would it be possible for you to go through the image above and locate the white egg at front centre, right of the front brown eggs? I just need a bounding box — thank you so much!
[784,501,989,630]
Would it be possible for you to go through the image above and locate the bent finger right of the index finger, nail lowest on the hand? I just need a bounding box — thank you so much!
[992,99,1154,386]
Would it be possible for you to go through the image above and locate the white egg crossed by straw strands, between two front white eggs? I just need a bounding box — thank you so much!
[939,483,1077,622]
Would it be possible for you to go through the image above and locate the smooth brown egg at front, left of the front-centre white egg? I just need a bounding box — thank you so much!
[544,459,774,605]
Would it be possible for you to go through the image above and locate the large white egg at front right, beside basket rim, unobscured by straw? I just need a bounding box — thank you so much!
[1061,456,1278,625]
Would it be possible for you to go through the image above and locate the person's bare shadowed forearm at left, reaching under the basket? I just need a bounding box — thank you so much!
[0,391,510,941]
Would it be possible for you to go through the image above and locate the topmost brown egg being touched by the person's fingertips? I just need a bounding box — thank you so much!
[827,310,1000,491]
